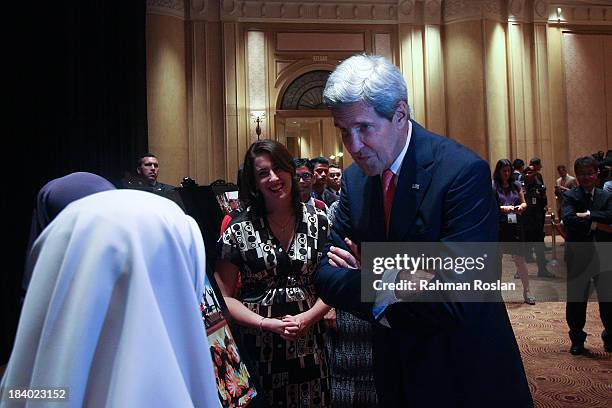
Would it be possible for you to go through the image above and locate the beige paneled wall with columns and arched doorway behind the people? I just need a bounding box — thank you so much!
[147,0,612,193]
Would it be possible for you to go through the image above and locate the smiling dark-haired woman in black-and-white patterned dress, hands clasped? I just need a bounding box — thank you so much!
[215,140,330,407]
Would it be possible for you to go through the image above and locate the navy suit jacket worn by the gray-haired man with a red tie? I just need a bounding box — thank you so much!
[315,122,533,407]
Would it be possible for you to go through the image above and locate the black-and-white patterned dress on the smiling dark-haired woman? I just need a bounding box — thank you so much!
[220,205,330,407]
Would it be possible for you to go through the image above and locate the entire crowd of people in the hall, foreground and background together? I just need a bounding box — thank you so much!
[2,55,612,408]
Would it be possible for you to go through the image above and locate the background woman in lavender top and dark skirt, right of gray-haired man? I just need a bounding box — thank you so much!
[493,159,535,305]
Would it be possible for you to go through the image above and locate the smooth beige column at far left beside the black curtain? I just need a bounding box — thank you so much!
[147,14,189,185]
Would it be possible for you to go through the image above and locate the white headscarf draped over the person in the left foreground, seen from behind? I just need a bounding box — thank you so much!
[2,190,219,407]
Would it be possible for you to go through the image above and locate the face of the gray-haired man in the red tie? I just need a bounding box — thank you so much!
[331,101,408,176]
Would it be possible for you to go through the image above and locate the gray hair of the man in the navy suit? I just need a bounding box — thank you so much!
[323,54,411,120]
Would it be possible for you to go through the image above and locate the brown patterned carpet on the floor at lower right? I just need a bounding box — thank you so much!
[507,302,612,408]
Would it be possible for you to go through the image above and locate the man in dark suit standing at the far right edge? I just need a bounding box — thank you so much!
[561,156,612,355]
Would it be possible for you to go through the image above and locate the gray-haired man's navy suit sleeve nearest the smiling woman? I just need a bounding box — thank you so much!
[314,173,373,321]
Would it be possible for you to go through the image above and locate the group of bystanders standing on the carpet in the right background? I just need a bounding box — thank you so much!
[493,151,612,355]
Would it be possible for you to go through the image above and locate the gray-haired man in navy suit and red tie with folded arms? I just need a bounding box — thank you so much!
[315,55,533,408]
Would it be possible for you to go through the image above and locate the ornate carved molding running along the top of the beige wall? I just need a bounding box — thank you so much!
[147,0,612,25]
